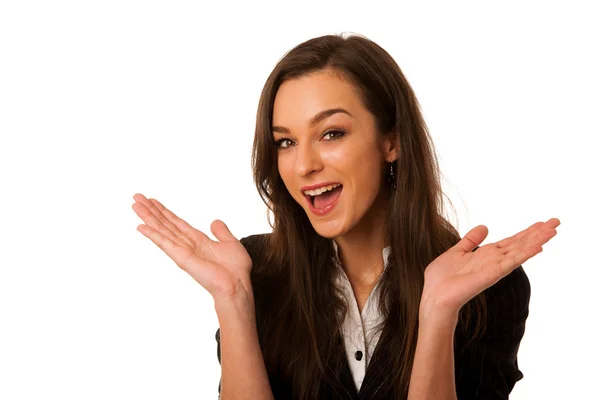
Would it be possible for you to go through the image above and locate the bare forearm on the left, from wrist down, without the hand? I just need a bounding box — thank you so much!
[215,290,274,400]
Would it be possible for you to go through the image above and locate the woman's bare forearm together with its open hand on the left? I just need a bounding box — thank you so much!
[132,193,273,400]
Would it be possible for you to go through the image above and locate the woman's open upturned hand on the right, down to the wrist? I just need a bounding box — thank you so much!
[421,218,560,316]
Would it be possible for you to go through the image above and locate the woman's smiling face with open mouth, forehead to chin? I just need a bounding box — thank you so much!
[272,70,396,238]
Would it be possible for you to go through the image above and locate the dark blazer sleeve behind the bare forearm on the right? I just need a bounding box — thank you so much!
[455,266,531,400]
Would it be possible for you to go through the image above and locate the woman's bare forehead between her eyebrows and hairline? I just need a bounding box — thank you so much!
[273,70,366,126]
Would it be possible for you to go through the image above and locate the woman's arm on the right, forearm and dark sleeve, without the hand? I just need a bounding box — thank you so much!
[408,266,531,400]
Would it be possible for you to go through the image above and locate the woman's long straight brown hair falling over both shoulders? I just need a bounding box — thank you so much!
[246,35,485,399]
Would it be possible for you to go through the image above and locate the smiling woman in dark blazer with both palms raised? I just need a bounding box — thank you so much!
[133,35,560,400]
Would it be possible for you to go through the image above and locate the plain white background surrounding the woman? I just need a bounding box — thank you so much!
[0,0,600,400]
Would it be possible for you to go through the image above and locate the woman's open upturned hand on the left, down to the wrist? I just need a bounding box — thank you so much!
[132,193,252,300]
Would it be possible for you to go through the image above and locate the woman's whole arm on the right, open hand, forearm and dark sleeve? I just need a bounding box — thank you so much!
[408,218,560,400]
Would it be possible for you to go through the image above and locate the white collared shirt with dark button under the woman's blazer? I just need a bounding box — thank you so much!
[333,241,390,390]
